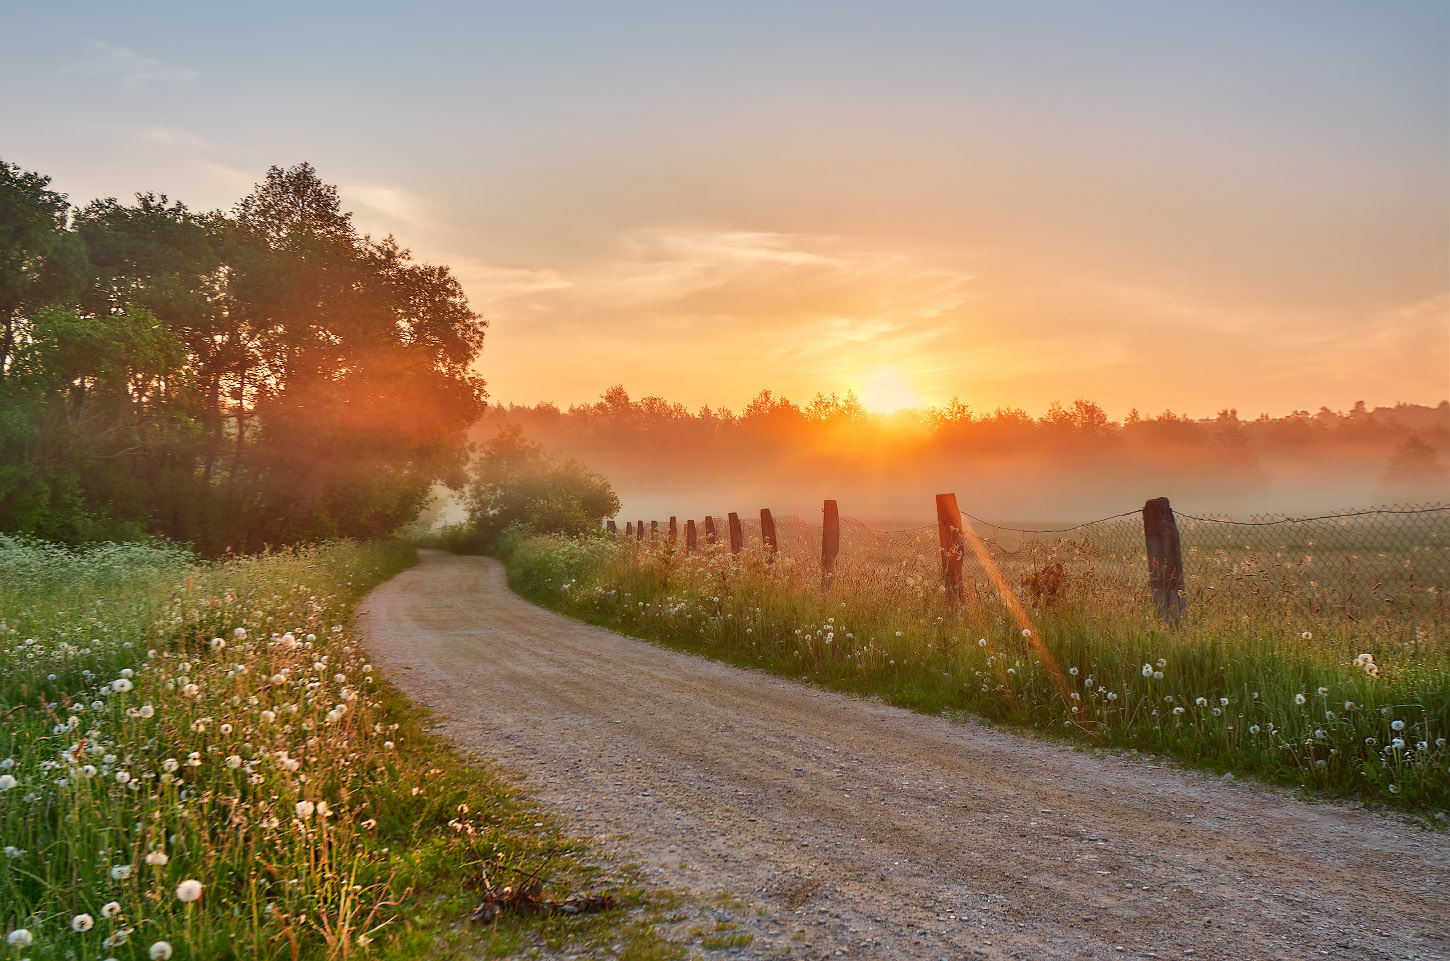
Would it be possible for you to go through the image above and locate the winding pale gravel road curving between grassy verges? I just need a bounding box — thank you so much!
[353,552,1450,958]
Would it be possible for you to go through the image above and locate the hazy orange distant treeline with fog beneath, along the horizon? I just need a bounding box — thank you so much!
[473,387,1450,525]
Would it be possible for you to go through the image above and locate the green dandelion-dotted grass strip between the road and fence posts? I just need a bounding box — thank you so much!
[503,538,1450,818]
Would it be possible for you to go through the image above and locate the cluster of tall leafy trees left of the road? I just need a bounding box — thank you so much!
[0,161,487,552]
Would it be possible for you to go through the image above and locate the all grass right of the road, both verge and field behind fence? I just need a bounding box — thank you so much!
[505,509,1450,819]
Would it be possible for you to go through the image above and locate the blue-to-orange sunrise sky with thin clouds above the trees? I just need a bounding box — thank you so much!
[0,0,1450,417]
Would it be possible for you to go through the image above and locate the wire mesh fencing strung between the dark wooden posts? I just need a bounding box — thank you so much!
[635,504,1450,646]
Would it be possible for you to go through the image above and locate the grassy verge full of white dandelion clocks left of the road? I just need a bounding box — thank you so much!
[0,538,682,960]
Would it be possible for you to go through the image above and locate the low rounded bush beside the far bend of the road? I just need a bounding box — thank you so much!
[467,425,619,548]
